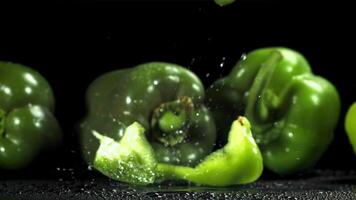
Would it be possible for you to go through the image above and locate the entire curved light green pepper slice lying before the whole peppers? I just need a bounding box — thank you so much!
[94,117,263,186]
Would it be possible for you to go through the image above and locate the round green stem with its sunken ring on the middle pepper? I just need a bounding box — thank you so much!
[151,96,194,146]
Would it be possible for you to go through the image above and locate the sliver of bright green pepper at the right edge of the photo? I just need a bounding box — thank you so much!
[345,102,356,153]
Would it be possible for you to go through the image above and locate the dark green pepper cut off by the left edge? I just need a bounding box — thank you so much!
[0,62,62,169]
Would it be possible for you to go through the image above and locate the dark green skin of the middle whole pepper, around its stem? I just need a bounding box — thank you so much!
[80,62,216,166]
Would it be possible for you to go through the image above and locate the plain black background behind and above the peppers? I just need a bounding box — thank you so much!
[0,0,356,179]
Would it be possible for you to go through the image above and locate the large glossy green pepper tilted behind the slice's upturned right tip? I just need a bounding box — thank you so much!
[207,48,340,175]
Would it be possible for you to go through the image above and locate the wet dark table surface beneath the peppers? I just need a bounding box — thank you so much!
[0,170,356,200]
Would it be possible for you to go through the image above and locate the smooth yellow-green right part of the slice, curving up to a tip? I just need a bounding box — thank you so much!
[157,117,263,186]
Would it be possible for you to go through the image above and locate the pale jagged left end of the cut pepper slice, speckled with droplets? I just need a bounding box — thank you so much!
[93,122,157,185]
